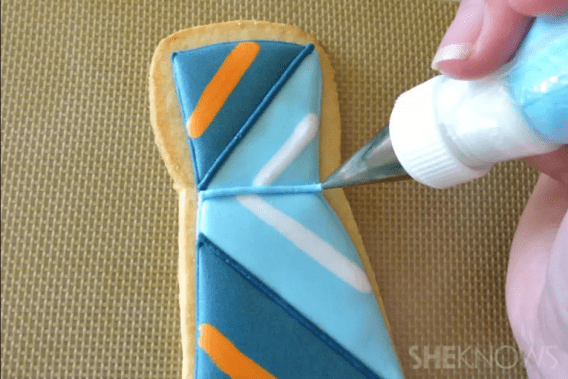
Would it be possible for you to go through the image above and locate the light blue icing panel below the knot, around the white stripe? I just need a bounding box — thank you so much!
[198,194,400,378]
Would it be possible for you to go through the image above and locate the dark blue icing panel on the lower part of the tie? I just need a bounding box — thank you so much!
[196,235,378,379]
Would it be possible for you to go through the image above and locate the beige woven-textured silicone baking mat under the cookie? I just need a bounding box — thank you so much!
[1,0,537,378]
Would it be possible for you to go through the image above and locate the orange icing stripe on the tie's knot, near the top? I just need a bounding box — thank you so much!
[187,42,260,138]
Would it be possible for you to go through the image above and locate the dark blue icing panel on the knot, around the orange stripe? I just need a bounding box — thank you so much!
[172,41,305,189]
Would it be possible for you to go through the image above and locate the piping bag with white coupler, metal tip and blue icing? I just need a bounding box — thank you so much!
[322,13,568,189]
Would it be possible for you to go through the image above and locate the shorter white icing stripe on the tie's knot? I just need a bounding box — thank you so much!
[253,113,319,186]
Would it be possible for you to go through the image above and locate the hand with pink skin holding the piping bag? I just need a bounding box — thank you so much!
[432,0,568,378]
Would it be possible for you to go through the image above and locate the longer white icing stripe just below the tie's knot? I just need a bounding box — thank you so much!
[237,195,371,293]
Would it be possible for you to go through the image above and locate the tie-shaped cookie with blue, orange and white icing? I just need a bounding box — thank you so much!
[150,22,402,378]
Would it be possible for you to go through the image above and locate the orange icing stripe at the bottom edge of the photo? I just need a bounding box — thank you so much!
[197,324,276,379]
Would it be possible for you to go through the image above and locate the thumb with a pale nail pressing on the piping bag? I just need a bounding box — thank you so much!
[432,0,532,79]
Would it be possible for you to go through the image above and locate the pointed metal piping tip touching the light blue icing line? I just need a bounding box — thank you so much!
[321,125,410,189]
